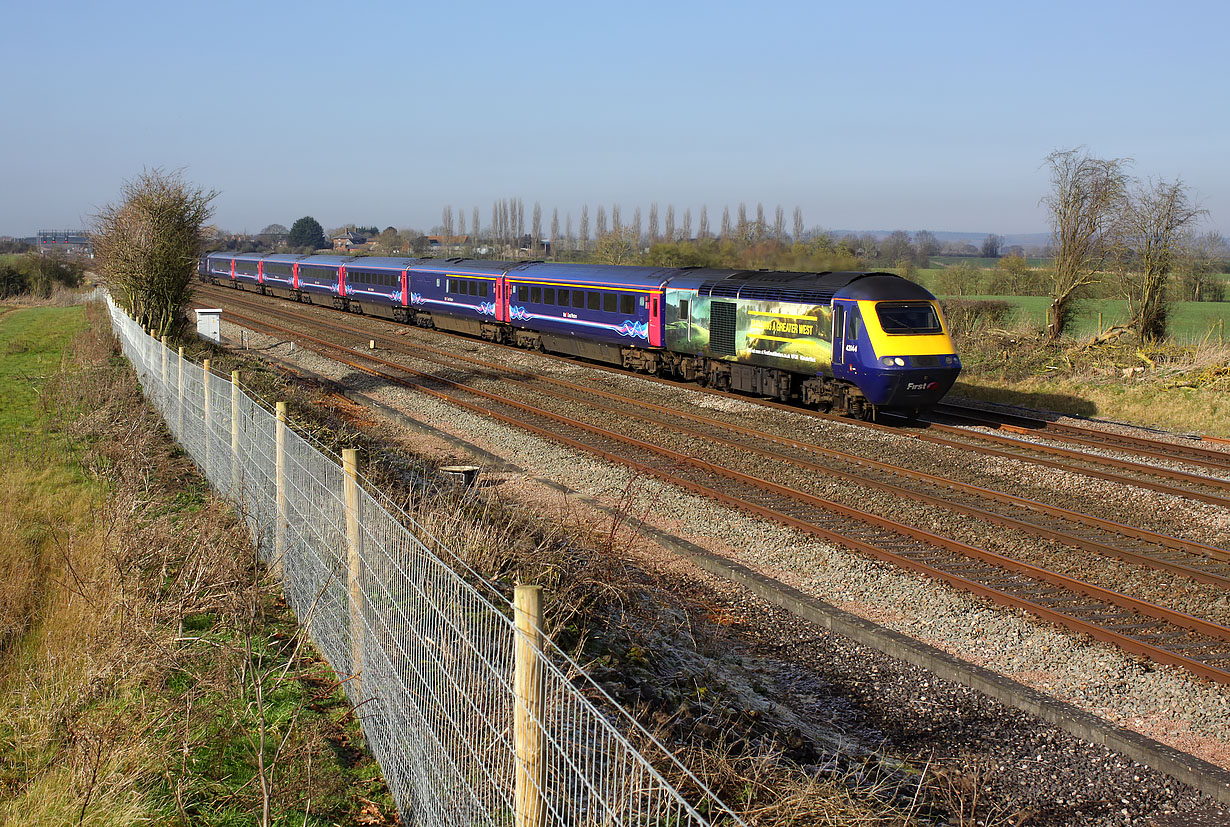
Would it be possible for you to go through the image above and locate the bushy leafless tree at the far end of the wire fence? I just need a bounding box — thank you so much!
[90,169,218,336]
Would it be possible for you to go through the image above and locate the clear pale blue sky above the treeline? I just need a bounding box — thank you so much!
[0,0,1230,235]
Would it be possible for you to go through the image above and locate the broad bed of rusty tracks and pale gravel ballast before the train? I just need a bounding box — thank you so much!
[189,288,1230,822]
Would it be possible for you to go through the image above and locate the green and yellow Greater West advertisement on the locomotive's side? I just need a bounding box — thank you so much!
[665,290,833,373]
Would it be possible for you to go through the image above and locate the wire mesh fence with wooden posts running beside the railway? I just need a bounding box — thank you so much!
[108,299,743,827]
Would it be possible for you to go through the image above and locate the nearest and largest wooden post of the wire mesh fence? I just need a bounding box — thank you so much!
[513,585,546,827]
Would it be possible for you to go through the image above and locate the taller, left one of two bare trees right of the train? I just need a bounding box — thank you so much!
[1042,148,1130,340]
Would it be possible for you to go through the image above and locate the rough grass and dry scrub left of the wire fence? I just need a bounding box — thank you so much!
[0,305,394,825]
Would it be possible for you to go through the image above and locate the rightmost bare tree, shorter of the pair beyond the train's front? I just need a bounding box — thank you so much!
[1119,178,1208,340]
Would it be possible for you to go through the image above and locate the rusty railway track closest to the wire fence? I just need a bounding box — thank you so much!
[209,303,1230,683]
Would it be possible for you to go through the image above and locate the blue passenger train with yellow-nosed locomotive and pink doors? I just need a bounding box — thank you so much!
[198,252,961,420]
